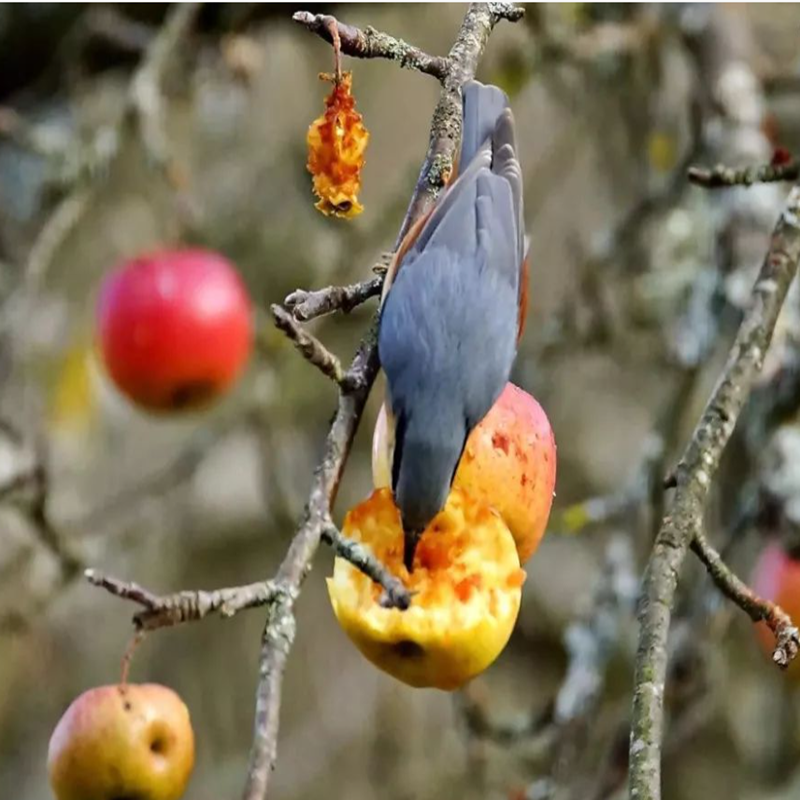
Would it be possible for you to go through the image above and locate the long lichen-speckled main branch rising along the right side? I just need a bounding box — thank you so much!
[630,187,800,800]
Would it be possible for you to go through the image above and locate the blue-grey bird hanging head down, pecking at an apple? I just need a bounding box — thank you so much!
[378,80,529,572]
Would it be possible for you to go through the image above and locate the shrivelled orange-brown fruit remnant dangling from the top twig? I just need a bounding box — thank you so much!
[307,72,369,219]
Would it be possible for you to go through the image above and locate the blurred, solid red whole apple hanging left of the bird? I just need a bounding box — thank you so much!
[97,249,253,412]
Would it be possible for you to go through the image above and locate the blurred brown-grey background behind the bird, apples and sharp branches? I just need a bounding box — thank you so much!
[0,3,800,800]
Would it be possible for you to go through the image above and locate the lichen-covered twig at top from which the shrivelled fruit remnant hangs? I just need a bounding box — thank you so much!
[292,11,448,81]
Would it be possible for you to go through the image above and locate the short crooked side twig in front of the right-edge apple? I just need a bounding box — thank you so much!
[692,530,800,669]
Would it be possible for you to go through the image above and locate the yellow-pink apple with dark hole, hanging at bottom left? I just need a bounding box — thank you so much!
[47,683,194,800]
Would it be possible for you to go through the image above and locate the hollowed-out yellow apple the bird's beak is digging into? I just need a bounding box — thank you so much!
[328,489,525,690]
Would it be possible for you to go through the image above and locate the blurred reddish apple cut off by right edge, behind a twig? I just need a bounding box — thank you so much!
[752,542,800,679]
